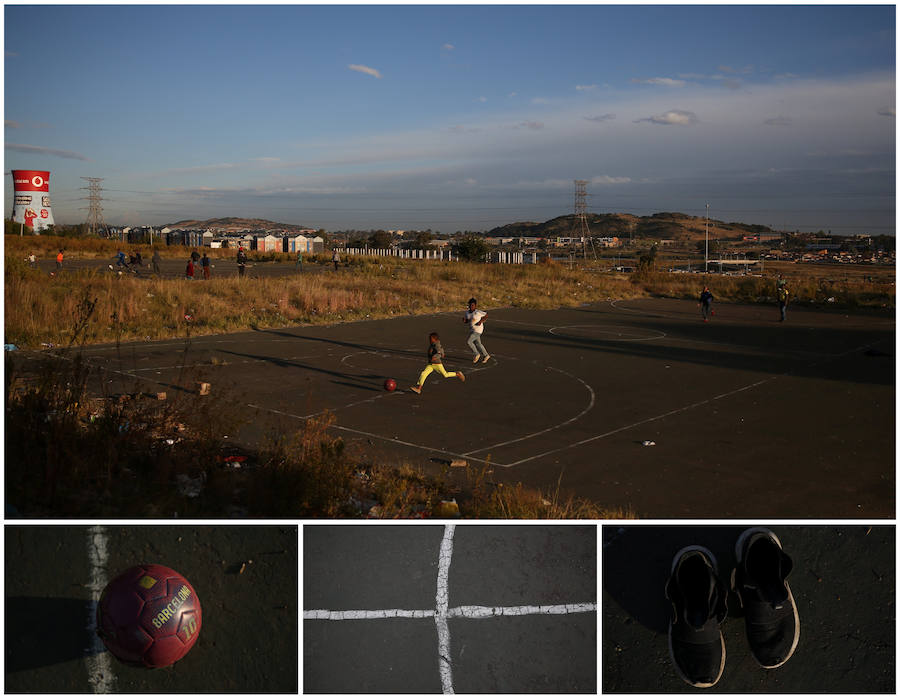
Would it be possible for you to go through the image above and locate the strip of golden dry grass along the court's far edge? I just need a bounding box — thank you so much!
[5,237,894,347]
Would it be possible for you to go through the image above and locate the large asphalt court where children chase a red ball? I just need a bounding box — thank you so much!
[68,299,895,518]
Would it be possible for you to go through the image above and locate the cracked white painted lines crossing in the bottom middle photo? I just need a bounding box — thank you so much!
[303,524,597,695]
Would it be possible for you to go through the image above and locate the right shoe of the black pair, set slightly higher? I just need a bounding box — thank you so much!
[731,527,800,668]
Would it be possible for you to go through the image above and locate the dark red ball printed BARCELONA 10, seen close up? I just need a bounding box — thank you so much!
[97,564,203,668]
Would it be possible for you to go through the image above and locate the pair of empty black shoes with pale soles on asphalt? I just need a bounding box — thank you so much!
[666,527,800,688]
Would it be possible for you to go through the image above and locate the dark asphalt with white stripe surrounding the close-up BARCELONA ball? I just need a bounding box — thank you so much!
[4,525,298,694]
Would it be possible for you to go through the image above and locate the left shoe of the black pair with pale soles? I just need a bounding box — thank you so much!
[666,545,728,688]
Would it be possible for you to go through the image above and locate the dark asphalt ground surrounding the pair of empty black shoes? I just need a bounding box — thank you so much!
[602,525,896,694]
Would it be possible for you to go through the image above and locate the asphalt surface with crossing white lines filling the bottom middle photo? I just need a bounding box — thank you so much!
[303,524,597,693]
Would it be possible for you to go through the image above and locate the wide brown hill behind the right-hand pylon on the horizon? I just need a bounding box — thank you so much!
[486,212,771,242]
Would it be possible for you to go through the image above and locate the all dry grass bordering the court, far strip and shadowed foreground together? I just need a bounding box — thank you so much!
[5,237,894,519]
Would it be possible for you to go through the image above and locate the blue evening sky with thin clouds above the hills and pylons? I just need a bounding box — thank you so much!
[3,5,896,235]
